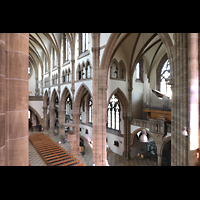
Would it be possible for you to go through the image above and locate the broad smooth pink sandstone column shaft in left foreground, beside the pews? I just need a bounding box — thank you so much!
[6,33,29,166]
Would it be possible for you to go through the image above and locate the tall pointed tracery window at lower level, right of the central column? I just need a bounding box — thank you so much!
[107,95,120,130]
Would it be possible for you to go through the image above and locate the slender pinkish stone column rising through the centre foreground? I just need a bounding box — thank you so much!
[92,41,107,166]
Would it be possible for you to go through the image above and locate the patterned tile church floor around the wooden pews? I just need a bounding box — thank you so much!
[29,131,155,166]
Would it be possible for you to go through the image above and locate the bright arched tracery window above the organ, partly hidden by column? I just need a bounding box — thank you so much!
[160,59,172,98]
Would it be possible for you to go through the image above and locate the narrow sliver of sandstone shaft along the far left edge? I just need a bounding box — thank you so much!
[0,33,6,166]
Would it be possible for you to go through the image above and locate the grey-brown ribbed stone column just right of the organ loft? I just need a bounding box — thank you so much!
[171,33,191,166]
